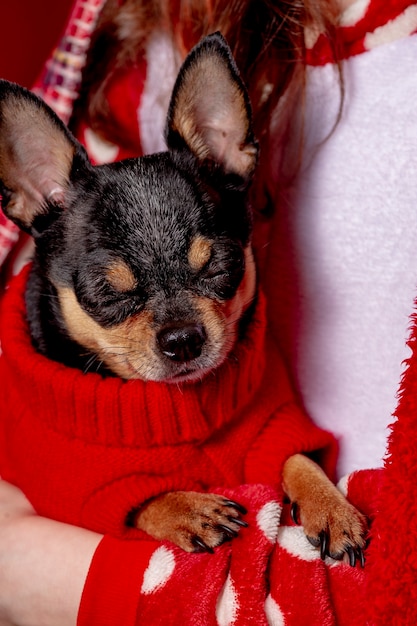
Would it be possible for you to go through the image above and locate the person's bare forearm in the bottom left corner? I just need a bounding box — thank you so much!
[0,480,102,626]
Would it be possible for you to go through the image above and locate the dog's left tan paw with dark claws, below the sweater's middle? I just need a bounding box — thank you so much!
[134,491,247,552]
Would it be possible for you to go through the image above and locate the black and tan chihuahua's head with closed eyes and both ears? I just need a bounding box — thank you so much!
[0,33,257,382]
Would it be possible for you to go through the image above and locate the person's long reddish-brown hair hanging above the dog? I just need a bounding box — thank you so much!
[70,0,336,209]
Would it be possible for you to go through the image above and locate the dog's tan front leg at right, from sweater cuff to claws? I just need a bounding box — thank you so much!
[283,454,367,565]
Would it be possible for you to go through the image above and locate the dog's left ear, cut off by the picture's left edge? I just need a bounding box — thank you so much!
[0,80,82,232]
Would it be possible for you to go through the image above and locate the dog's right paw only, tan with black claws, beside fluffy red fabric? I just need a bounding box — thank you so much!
[291,491,368,567]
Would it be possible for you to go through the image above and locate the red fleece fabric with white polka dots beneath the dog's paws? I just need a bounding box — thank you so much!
[133,471,381,626]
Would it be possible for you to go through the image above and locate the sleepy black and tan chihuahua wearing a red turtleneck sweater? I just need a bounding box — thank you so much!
[0,33,366,565]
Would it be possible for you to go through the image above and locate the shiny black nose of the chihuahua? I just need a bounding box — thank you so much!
[157,324,207,363]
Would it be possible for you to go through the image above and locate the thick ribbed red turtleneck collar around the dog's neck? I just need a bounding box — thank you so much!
[0,268,266,446]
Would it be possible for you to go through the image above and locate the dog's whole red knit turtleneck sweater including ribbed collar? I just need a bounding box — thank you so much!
[0,270,335,535]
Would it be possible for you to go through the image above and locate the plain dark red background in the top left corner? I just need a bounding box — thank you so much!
[0,0,73,87]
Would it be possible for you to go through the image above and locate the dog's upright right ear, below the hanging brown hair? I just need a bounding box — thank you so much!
[166,33,258,182]
